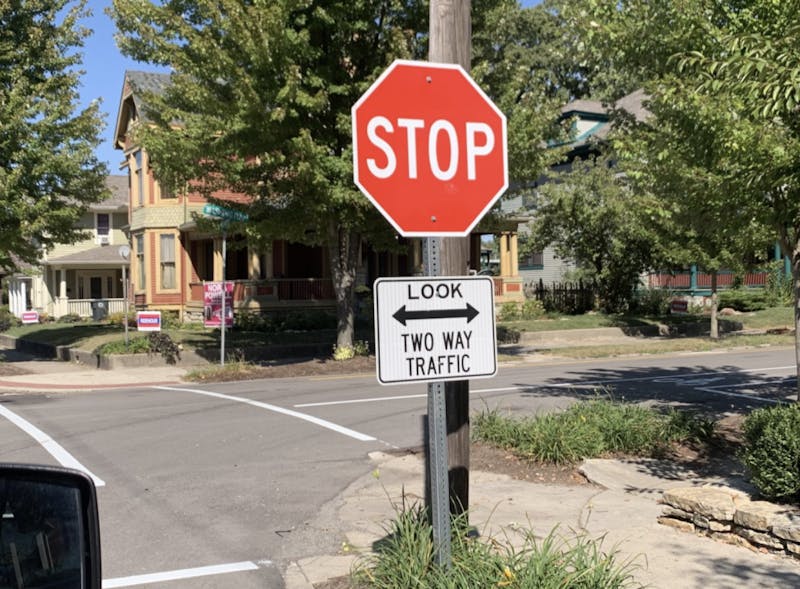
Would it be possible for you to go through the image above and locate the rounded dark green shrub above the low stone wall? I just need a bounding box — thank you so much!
[742,403,800,502]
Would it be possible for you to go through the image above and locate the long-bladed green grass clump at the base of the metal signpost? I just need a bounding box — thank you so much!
[353,504,640,589]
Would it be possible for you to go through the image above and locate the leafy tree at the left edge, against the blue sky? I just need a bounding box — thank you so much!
[0,0,107,269]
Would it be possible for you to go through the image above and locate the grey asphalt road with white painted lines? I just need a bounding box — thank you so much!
[0,349,795,589]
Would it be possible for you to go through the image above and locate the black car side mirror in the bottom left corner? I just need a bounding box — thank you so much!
[0,463,102,589]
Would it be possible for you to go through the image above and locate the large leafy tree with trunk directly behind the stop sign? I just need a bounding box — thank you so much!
[110,0,564,347]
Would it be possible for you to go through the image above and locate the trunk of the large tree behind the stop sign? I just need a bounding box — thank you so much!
[328,223,361,348]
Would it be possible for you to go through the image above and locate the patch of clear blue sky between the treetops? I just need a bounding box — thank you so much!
[80,0,541,174]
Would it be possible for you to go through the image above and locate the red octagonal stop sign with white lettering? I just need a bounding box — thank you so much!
[352,60,508,237]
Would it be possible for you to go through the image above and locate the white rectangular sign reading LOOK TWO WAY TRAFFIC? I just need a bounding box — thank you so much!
[373,276,497,384]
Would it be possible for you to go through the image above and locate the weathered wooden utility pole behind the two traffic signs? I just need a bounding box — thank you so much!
[428,0,472,514]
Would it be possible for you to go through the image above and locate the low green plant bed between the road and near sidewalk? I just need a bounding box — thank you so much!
[473,399,714,464]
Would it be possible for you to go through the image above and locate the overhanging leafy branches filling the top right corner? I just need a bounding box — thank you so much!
[582,0,800,386]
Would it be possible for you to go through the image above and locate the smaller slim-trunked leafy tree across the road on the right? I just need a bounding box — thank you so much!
[615,85,774,338]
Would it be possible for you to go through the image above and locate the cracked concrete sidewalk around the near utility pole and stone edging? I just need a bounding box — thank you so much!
[285,453,800,589]
